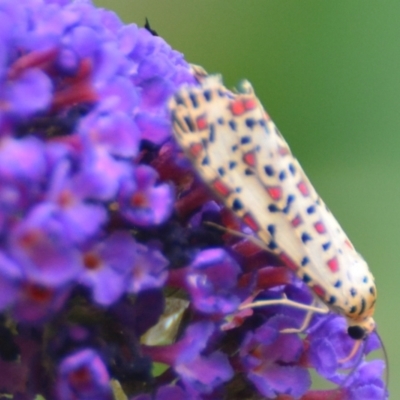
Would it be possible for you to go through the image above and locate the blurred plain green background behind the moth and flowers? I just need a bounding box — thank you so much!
[95,0,400,399]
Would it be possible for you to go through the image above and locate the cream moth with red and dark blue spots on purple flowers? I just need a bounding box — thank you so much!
[169,76,377,339]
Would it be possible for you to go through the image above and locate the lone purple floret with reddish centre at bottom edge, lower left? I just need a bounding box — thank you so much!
[57,349,113,400]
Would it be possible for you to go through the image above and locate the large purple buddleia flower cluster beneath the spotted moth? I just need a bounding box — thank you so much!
[0,0,386,400]
